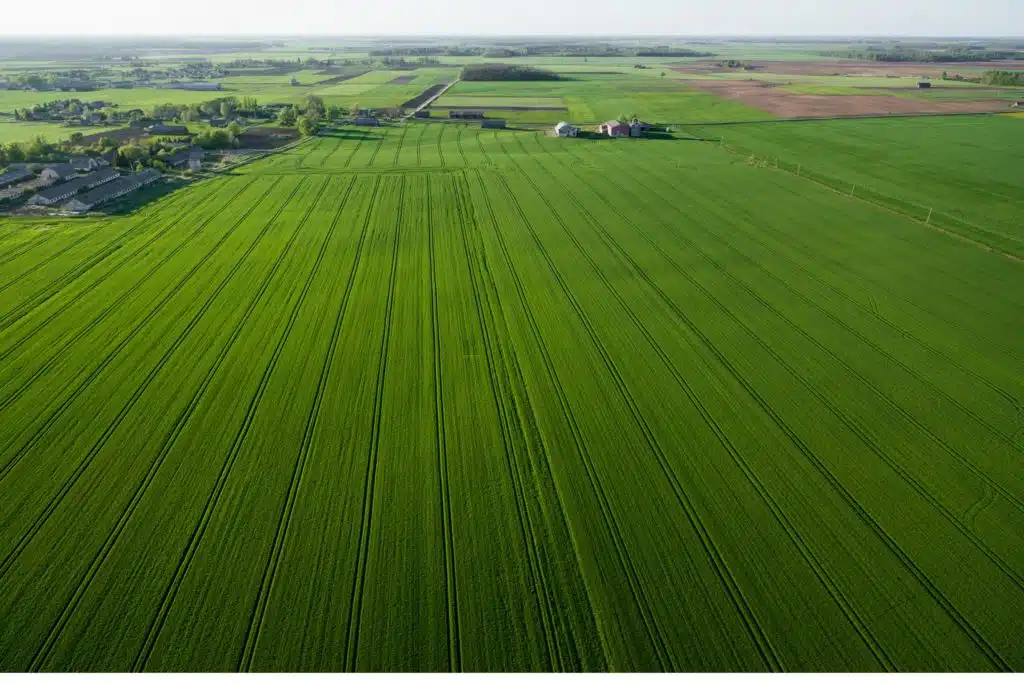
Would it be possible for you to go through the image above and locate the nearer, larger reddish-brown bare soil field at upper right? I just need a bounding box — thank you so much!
[687,81,1007,119]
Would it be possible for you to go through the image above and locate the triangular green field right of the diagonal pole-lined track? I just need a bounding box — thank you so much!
[687,116,1024,257]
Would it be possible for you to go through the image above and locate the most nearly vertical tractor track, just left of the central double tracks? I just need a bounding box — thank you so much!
[424,176,462,672]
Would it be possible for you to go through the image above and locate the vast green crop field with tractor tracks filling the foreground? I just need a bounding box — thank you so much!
[0,118,1024,671]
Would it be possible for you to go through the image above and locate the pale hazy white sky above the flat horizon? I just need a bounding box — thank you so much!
[0,0,1024,36]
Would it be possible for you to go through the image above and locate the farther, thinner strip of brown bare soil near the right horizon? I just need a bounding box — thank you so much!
[672,59,1024,78]
